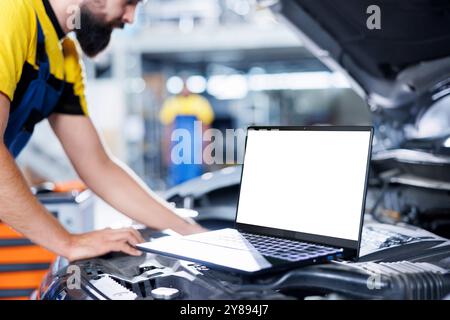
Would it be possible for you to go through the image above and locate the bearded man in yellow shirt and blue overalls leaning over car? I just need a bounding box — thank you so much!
[0,0,203,261]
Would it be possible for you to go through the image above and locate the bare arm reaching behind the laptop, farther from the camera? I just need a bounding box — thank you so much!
[49,114,205,234]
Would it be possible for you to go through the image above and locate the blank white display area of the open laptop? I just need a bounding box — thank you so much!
[236,130,371,241]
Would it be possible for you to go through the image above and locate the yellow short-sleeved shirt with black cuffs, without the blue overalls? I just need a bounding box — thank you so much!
[0,0,87,115]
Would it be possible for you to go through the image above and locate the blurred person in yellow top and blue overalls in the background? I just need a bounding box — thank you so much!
[160,79,214,186]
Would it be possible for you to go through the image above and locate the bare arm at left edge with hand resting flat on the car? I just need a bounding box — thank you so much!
[0,92,142,261]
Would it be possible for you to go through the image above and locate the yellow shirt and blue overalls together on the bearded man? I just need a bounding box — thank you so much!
[0,0,87,157]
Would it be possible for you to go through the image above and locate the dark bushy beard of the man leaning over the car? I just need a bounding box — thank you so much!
[75,7,114,58]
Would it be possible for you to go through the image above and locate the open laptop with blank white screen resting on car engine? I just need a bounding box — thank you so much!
[137,126,373,275]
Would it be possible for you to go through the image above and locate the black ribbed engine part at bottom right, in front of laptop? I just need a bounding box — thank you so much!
[225,262,450,300]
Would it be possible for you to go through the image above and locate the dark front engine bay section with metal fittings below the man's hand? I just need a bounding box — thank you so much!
[37,254,288,300]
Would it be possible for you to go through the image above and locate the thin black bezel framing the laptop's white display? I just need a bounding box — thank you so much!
[234,126,374,260]
